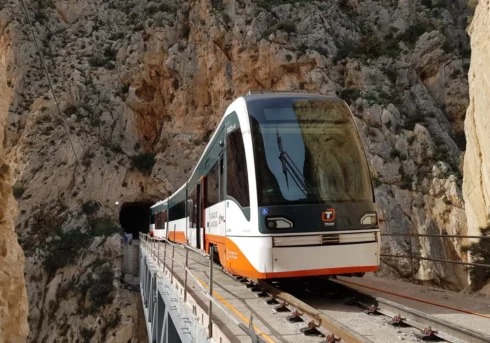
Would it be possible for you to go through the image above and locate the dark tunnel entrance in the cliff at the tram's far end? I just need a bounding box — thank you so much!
[119,202,152,239]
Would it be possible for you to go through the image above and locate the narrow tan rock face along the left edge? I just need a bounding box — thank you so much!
[0,6,29,343]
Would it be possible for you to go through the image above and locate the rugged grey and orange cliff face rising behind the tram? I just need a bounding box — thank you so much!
[0,0,470,343]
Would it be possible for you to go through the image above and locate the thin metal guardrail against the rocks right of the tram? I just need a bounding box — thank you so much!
[380,229,490,283]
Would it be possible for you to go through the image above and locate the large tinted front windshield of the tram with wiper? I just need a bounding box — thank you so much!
[247,98,373,206]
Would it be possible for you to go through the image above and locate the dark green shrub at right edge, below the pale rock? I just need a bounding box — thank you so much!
[461,226,490,290]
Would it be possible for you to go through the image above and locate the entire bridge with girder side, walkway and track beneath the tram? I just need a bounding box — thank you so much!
[138,234,490,343]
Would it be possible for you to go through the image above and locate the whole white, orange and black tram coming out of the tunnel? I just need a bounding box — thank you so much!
[151,92,380,279]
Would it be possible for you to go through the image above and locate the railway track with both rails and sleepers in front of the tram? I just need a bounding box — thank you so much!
[150,242,490,343]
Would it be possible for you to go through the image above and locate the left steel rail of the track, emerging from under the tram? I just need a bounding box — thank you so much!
[254,280,373,343]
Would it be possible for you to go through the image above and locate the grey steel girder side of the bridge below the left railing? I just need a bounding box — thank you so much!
[139,234,263,343]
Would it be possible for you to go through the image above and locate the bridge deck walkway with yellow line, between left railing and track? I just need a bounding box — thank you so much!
[142,243,328,343]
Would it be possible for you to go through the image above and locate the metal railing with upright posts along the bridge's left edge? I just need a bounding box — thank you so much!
[139,232,265,343]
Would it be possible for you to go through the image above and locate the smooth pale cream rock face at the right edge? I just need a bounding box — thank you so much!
[463,0,490,239]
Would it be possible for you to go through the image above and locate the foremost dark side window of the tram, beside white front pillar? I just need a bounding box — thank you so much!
[226,130,250,207]
